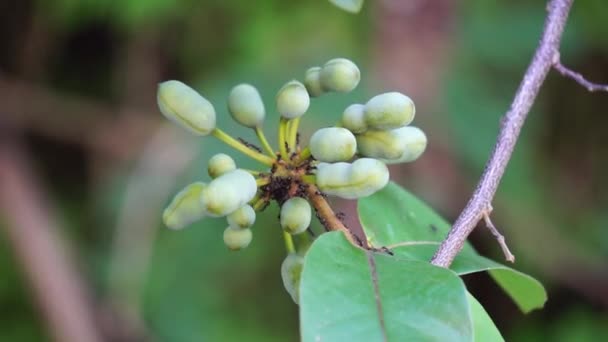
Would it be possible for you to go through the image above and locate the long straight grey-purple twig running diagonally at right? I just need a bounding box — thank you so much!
[431,0,573,267]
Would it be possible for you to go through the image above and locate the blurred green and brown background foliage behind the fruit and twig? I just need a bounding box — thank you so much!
[0,0,608,342]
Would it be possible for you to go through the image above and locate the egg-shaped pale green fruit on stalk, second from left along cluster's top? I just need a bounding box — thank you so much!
[228,83,266,128]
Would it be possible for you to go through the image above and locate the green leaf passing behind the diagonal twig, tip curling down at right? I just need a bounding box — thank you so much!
[358,182,547,312]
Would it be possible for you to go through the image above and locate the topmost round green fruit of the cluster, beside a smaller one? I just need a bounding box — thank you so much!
[320,58,361,93]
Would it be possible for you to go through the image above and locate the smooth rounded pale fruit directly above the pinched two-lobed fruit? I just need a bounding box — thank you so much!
[310,127,357,163]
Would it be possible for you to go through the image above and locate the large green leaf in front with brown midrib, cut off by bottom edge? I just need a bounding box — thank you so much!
[300,232,473,341]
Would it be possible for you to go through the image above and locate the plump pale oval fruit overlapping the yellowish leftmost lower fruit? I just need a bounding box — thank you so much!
[200,169,257,217]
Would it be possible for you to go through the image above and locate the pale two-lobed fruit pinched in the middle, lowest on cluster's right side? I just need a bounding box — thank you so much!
[317,158,389,199]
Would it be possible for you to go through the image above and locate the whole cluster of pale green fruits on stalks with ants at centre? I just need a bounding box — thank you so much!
[158,58,427,301]
